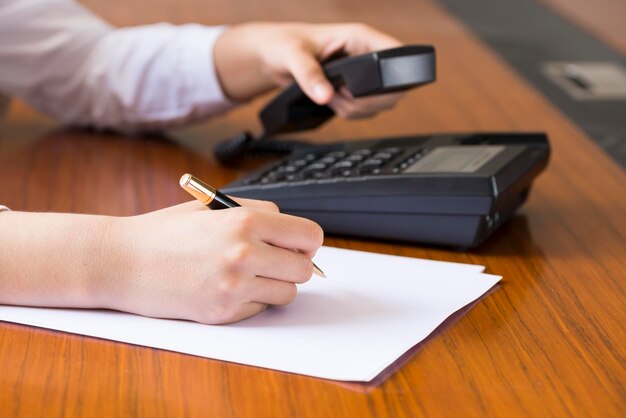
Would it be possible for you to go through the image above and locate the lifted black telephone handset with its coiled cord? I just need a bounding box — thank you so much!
[215,45,435,164]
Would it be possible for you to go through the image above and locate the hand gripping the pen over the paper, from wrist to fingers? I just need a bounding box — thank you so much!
[100,200,323,324]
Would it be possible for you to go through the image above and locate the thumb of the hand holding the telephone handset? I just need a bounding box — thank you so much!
[287,49,334,105]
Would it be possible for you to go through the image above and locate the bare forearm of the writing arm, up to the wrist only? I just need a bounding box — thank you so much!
[0,212,112,308]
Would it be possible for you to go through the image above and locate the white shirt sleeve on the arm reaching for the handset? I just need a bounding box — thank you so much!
[0,0,233,131]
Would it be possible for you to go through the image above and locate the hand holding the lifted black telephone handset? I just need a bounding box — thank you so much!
[214,23,401,118]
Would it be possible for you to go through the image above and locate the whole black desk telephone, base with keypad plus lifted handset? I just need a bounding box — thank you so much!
[216,46,550,248]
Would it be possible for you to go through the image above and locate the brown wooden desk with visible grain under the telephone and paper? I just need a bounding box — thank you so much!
[0,0,626,418]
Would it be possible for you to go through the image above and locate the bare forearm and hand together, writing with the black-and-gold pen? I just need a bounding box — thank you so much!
[0,199,323,324]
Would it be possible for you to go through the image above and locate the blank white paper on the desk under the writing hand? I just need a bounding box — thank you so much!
[0,247,500,382]
